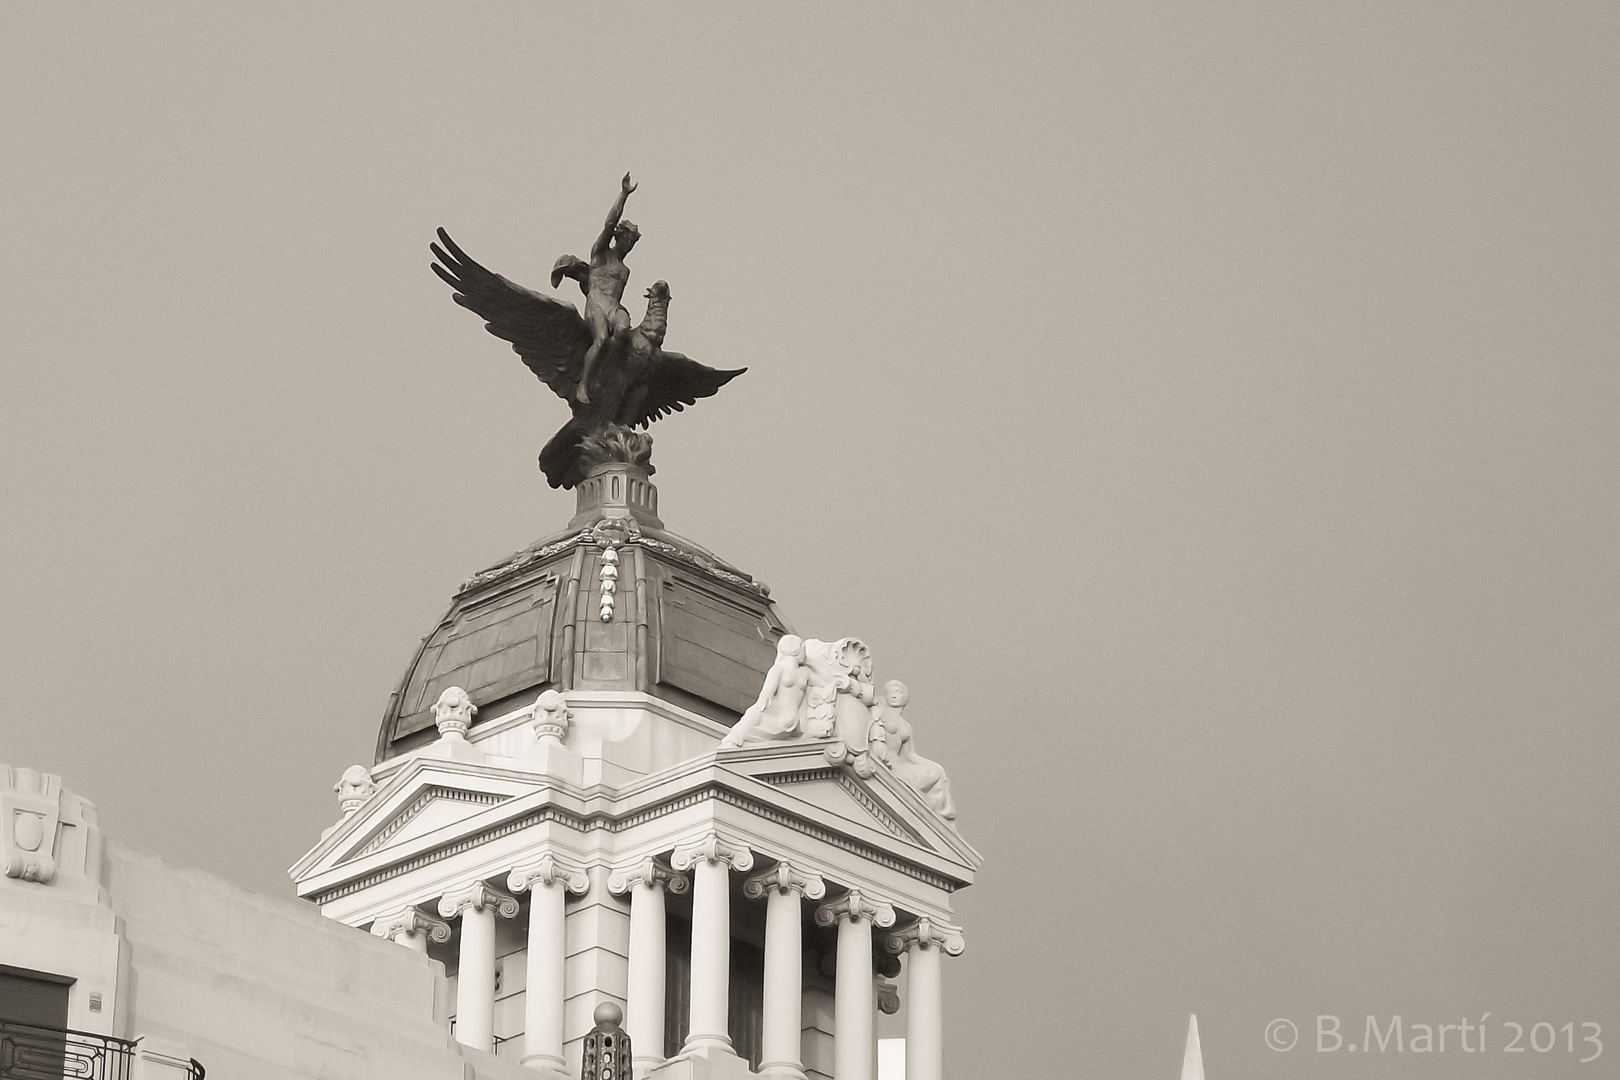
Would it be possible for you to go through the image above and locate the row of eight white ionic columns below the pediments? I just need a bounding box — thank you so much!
[373,832,962,1080]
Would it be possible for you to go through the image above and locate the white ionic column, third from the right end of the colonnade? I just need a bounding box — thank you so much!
[742,861,826,1080]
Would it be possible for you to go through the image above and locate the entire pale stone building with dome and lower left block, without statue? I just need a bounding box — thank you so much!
[0,461,980,1080]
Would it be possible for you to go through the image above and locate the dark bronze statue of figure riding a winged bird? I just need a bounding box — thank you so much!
[429,176,747,487]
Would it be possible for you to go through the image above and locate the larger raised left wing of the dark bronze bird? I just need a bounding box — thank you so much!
[429,228,592,402]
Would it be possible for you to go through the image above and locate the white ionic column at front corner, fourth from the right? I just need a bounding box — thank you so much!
[667,832,753,1054]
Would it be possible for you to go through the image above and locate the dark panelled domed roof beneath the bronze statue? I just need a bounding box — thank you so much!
[377,463,791,763]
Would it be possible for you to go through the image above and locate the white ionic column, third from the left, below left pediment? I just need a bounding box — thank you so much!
[508,855,591,1075]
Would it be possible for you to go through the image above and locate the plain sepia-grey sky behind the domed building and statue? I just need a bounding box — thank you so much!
[0,2,1620,1080]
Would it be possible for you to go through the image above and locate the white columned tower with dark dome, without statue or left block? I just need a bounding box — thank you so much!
[290,463,980,1080]
